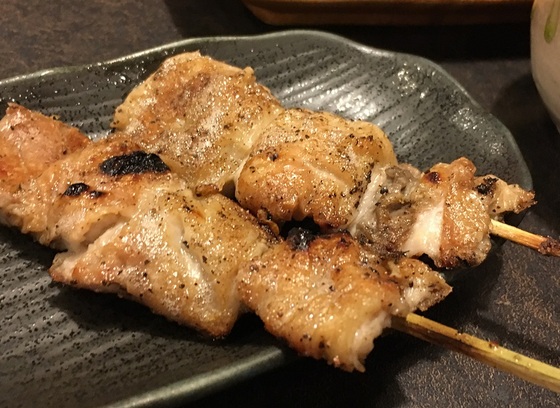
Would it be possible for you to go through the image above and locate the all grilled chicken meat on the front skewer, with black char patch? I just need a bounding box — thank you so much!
[0,104,451,370]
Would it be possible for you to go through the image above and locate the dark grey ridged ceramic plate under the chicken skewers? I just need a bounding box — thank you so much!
[0,31,531,407]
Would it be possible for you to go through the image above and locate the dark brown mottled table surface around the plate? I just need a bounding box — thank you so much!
[0,0,560,407]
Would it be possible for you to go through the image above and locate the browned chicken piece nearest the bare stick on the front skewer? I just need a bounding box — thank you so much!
[239,231,450,371]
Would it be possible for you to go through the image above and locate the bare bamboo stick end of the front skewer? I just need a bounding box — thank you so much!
[392,313,560,393]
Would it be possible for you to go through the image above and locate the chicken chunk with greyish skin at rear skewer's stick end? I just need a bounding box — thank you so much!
[349,158,534,268]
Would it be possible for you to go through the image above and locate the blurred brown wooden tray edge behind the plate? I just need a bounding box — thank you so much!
[242,0,532,25]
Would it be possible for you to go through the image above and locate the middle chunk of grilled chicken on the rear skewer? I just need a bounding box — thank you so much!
[236,109,397,228]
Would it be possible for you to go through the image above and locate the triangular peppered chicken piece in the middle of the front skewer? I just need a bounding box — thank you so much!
[50,171,274,336]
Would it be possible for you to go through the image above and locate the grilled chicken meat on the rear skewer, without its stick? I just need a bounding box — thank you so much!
[109,52,544,268]
